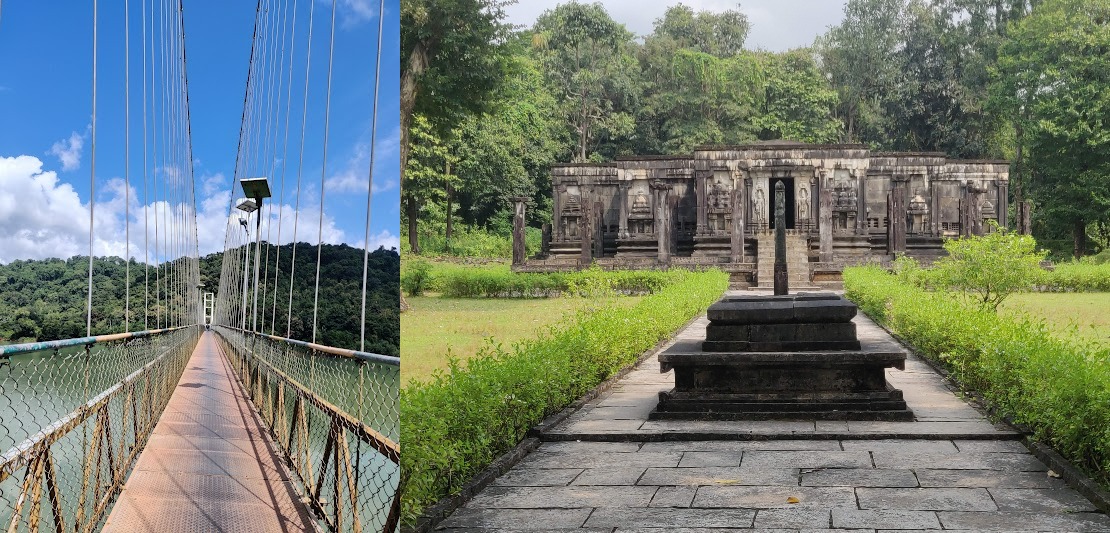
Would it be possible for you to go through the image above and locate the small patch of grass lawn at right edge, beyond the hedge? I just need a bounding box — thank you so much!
[1002,292,1110,346]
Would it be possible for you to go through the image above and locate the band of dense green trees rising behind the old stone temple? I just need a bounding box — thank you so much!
[405,0,1110,259]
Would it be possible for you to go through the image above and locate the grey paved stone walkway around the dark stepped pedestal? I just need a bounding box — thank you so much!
[438,302,1110,533]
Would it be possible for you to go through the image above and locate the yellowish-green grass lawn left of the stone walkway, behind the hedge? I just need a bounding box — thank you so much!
[401,296,640,383]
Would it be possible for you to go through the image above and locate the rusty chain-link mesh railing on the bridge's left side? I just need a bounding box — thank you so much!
[0,326,200,532]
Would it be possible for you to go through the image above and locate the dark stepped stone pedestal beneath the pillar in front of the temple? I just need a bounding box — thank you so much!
[650,293,914,421]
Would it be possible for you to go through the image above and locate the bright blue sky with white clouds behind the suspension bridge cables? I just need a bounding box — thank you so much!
[0,0,400,262]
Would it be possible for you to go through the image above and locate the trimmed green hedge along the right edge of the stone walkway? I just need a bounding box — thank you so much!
[844,267,1110,486]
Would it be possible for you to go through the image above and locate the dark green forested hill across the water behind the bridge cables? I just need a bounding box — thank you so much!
[0,242,401,355]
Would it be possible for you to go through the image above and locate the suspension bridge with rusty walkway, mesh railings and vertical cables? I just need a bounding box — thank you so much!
[0,0,400,532]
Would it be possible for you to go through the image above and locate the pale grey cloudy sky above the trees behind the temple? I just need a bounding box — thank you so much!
[505,0,847,52]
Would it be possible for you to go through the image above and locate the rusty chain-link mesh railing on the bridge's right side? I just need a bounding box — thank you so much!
[208,326,401,533]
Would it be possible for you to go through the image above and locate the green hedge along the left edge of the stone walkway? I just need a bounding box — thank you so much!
[401,271,728,523]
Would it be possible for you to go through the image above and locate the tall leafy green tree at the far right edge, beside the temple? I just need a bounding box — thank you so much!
[992,0,1110,257]
